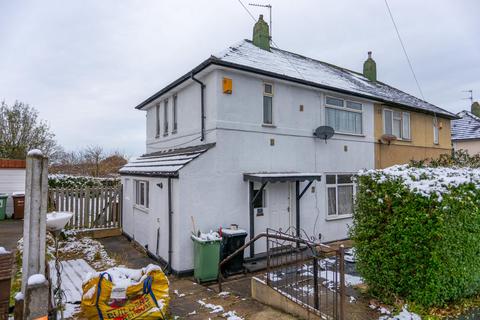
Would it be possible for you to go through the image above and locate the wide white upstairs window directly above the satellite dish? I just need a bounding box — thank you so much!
[325,96,363,134]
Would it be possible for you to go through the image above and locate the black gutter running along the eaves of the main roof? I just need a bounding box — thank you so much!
[135,56,460,119]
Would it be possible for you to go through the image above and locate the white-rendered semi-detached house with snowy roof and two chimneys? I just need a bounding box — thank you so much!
[120,16,455,272]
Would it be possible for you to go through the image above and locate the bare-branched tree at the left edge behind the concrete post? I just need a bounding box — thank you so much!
[0,101,59,159]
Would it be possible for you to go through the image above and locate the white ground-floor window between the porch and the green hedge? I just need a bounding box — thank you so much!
[325,173,356,219]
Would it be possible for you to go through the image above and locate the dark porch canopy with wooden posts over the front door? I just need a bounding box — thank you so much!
[243,172,322,257]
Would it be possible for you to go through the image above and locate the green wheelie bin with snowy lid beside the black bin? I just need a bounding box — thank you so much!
[192,235,222,283]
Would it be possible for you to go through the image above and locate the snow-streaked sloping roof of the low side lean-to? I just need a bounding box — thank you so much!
[119,144,215,176]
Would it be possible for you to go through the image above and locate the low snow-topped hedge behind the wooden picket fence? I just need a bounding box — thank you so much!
[48,174,120,188]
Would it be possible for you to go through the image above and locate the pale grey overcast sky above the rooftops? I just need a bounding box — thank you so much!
[0,0,480,155]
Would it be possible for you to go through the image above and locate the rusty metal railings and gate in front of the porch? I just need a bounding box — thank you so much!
[266,229,346,320]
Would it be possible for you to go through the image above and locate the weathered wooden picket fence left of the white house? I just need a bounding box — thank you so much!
[48,185,122,230]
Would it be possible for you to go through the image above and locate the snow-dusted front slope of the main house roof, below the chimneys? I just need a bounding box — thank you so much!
[213,40,456,118]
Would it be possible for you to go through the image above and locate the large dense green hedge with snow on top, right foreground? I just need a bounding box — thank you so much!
[350,166,480,307]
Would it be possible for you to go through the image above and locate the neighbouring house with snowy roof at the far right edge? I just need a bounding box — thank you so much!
[452,102,480,155]
